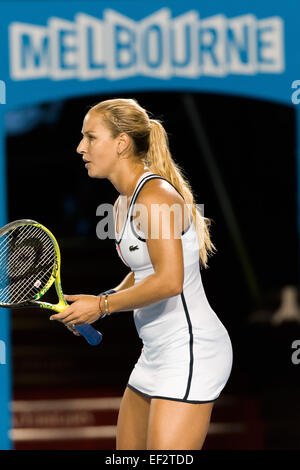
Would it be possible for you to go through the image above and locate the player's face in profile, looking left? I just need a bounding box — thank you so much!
[77,112,118,178]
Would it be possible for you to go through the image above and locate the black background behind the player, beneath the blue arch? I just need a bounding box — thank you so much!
[6,92,300,449]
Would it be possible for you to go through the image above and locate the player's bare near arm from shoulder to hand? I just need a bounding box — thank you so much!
[51,185,184,325]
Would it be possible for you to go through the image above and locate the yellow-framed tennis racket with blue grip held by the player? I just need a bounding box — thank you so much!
[0,219,102,346]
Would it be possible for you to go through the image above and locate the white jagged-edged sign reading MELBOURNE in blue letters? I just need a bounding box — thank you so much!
[9,8,284,80]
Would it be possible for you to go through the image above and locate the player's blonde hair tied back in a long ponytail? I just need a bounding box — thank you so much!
[90,98,217,268]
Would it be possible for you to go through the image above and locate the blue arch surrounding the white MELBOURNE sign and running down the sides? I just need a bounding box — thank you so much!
[0,0,300,450]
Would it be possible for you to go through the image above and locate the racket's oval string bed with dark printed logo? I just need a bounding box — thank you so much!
[0,225,56,304]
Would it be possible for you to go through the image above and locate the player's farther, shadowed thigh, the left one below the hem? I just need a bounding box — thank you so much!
[116,387,151,450]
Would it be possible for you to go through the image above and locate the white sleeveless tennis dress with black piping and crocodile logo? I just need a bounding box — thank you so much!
[115,171,232,403]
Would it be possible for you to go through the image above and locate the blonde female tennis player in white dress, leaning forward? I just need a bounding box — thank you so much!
[51,99,232,450]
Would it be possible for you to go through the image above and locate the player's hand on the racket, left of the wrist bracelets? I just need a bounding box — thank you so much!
[50,294,101,326]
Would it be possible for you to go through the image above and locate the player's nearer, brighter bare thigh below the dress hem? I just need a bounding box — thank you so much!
[147,398,214,450]
